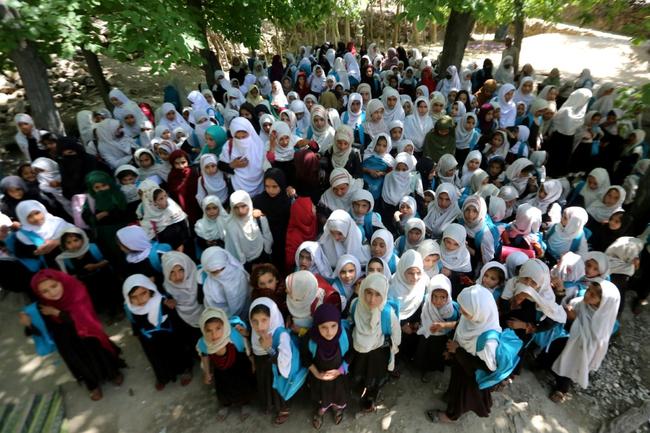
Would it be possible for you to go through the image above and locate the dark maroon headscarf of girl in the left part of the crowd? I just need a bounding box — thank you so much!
[167,149,201,226]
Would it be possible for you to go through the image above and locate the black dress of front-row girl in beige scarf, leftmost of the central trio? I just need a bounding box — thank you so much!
[207,343,255,407]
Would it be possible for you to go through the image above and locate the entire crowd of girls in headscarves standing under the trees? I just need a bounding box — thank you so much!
[5,38,650,428]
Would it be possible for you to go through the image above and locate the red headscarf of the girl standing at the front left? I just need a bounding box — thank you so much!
[31,269,118,355]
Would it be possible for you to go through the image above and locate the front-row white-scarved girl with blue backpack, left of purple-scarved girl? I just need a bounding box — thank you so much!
[248,298,307,425]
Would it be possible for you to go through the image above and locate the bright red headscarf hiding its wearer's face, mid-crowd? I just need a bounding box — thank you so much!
[285,197,318,272]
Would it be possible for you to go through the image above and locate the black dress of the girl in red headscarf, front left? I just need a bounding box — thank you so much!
[26,311,126,391]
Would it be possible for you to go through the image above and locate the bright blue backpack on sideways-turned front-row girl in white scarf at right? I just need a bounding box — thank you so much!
[475,328,524,389]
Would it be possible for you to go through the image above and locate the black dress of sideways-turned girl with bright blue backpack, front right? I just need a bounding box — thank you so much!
[445,347,492,420]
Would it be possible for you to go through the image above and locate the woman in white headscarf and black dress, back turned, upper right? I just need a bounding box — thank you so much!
[546,89,591,178]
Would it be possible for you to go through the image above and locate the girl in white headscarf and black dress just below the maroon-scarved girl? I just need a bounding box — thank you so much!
[137,180,190,251]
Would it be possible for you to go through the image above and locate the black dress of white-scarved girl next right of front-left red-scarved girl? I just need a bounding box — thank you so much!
[130,301,192,385]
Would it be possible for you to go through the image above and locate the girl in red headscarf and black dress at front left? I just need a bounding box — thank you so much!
[20,269,126,401]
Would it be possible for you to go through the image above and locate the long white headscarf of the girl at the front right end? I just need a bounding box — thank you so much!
[553,280,621,388]
